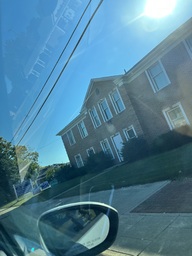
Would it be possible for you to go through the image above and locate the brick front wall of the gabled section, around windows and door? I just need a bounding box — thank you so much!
[62,80,143,166]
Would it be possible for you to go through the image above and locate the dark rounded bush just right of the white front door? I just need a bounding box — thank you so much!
[122,138,149,162]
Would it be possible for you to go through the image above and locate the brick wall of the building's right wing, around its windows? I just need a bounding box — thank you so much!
[125,42,192,141]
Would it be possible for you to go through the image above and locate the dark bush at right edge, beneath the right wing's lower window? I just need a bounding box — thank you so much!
[152,125,192,153]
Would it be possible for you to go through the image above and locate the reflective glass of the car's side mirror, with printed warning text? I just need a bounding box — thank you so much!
[39,207,110,255]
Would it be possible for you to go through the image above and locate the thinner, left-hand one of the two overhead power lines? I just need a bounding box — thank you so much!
[11,0,92,142]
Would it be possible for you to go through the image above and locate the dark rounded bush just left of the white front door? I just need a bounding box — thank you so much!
[85,151,114,172]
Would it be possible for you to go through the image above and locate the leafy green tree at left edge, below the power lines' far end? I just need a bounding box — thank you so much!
[0,137,39,202]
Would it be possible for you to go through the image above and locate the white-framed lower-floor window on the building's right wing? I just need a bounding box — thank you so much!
[163,103,189,130]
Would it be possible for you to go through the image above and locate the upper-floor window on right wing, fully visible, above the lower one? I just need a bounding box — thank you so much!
[147,61,170,92]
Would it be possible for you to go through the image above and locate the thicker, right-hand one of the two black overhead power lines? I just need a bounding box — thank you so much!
[17,0,104,146]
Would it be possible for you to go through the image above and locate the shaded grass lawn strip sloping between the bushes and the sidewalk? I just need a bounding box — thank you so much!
[22,144,192,206]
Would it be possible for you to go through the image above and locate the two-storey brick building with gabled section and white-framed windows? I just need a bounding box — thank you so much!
[58,19,192,167]
